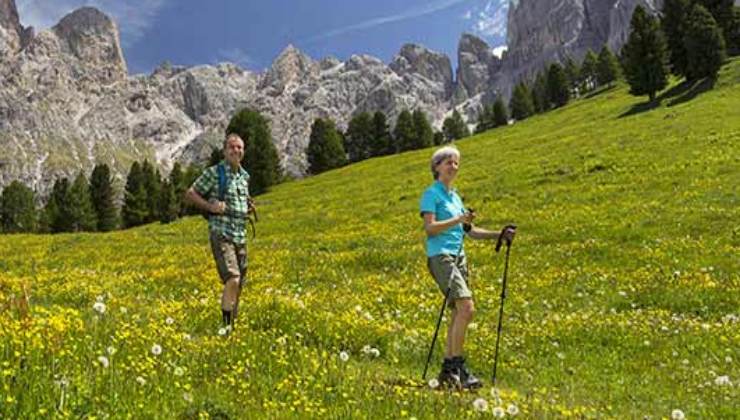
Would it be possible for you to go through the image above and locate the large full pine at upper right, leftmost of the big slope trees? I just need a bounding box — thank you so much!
[622,6,668,101]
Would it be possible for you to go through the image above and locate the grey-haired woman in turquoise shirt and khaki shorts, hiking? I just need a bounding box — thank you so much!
[421,146,514,389]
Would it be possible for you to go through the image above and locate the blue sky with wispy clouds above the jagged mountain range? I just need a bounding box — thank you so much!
[16,0,508,73]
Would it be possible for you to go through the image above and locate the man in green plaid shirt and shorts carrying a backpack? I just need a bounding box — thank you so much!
[185,134,251,330]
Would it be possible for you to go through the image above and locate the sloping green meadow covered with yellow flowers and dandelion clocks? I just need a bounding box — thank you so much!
[0,60,740,419]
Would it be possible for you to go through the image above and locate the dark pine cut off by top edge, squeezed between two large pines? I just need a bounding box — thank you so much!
[660,0,691,76]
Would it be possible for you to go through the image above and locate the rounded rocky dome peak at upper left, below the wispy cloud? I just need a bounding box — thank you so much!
[52,7,128,82]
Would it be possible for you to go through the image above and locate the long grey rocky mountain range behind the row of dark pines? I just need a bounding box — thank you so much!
[0,0,660,196]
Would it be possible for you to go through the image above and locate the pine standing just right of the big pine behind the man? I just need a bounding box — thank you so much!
[306,118,347,175]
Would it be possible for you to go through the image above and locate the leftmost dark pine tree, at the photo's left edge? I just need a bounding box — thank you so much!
[0,181,36,233]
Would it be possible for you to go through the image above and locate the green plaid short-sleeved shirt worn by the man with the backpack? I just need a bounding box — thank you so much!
[193,160,249,244]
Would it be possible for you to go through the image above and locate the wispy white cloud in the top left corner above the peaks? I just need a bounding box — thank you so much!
[16,0,169,47]
